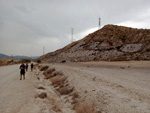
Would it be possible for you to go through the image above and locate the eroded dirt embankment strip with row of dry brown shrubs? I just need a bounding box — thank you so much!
[35,65,98,113]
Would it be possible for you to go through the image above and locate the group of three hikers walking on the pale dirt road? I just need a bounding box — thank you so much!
[20,63,34,80]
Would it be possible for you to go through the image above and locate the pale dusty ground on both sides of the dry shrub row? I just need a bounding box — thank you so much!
[0,61,150,113]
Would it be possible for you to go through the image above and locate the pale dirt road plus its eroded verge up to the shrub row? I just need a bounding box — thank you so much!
[0,65,72,113]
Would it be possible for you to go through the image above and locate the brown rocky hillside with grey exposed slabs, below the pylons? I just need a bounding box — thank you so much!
[39,25,150,62]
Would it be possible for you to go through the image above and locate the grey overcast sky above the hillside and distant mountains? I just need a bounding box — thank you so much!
[0,0,150,56]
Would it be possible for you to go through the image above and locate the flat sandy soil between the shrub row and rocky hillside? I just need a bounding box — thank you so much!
[45,61,150,113]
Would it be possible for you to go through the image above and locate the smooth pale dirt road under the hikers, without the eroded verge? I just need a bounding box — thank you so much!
[0,65,53,113]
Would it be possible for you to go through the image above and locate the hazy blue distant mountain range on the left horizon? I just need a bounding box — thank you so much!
[0,53,39,59]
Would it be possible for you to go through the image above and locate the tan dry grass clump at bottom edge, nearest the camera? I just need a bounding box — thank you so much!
[75,102,96,113]
